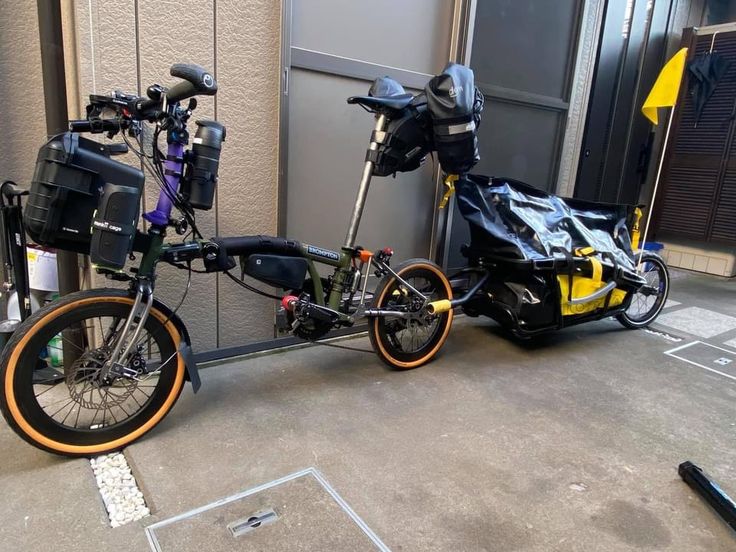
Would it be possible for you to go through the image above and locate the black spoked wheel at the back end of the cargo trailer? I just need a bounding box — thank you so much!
[616,251,670,330]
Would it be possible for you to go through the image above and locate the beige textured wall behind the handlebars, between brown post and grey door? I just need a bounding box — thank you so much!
[67,0,281,350]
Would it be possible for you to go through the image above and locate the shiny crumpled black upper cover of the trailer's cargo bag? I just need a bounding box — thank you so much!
[455,174,636,274]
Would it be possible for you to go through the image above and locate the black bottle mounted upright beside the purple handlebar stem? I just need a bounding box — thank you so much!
[182,121,225,211]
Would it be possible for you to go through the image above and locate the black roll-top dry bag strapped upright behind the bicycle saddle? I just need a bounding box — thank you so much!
[424,63,483,174]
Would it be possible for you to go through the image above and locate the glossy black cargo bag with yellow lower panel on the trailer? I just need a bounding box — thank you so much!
[455,174,642,315]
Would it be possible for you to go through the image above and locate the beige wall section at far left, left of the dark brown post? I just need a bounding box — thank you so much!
[0,0,46,186]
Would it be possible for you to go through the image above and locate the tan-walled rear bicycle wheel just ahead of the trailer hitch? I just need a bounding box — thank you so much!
[368,259,453,370]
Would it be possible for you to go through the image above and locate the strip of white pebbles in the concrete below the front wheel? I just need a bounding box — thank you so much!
[89,452,151,527]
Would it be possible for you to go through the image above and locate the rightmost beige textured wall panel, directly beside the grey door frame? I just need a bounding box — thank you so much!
[217,0,281,347]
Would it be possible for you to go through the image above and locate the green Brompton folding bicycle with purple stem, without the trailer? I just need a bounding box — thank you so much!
[0,64,453,456]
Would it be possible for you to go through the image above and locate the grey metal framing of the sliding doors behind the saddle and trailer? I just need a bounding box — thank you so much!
[277,0,606,267]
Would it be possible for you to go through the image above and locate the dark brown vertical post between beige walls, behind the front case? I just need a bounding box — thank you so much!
[37,0,79,295]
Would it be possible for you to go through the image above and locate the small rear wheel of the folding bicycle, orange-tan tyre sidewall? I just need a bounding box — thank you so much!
[368,259,452,370]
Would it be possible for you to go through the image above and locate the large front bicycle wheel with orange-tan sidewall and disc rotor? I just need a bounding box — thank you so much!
[0,289,185,456]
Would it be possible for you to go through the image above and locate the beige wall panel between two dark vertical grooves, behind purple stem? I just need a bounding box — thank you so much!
[138,0,218,351]
